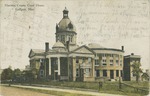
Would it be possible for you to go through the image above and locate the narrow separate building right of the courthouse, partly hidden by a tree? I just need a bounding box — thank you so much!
[123,53,141,81]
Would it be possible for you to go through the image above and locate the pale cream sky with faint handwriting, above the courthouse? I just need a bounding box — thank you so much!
[0,0,150,69]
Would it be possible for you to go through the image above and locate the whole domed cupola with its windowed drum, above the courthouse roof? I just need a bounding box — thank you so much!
[56,7,77,46]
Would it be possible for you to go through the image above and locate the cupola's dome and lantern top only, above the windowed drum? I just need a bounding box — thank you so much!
[56,7,76,32]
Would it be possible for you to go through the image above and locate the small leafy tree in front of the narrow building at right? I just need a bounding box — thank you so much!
[131,62,142,82]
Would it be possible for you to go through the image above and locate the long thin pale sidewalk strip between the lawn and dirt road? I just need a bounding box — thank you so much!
[4,85,123,96]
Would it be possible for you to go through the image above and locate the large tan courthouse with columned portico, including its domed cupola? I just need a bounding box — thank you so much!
[29,8,124,81]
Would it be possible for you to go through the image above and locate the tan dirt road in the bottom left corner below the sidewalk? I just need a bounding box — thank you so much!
[0,86,54,96]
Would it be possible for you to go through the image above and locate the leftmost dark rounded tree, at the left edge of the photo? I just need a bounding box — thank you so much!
[1,68,13,81]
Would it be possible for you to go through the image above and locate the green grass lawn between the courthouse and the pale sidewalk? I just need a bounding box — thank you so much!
[2,81,149,96]
